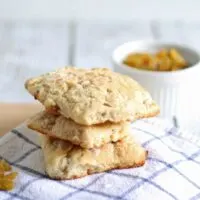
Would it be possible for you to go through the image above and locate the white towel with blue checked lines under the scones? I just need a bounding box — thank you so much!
[0,118,200,200]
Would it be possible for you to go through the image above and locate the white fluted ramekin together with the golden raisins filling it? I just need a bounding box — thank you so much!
[112,40,200,117]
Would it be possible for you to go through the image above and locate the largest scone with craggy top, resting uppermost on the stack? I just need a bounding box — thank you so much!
[25,67,159,125]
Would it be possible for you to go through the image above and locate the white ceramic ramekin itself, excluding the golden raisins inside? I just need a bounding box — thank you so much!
[112,41,200,122]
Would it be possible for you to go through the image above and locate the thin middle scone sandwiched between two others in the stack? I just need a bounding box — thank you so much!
[27,111,130,148]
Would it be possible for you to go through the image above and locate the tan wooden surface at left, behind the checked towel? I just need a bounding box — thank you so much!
[0,103,42,136]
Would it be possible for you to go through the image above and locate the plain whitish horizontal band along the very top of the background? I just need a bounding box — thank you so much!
[0,0,200,20]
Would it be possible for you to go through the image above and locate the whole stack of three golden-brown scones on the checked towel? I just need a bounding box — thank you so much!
[25,67,159,179]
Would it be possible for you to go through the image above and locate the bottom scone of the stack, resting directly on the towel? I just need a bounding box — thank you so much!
[41,135,147,179]
